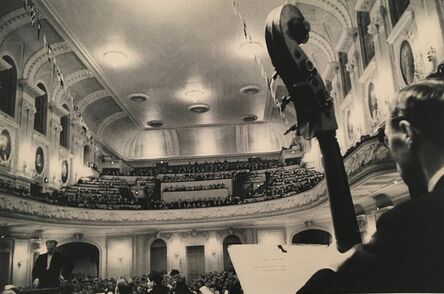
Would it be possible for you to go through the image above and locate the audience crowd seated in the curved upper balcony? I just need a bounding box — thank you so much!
[0,160,324,210]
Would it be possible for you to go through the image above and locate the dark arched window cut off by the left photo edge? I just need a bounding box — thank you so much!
[0,56,17,117]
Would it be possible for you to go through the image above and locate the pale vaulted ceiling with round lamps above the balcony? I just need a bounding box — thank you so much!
[4,0,354,159]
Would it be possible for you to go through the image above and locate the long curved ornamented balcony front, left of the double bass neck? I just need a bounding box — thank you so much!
[0,180,327,226]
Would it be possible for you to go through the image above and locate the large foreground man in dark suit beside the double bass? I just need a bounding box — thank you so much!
[298,70,444,293]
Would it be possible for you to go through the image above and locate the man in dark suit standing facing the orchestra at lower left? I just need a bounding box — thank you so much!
[32,240,74,289]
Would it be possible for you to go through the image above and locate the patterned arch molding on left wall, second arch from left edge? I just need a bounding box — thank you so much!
[23,41,72,81]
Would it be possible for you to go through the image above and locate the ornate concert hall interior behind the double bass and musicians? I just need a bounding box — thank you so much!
[0,0,444,294]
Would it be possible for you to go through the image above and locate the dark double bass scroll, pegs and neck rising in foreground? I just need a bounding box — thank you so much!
[265,4,361,252]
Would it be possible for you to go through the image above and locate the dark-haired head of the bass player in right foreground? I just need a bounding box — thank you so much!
[386,74,444,192]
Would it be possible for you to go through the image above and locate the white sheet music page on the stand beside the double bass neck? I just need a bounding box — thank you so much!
[228,245,352,294]
